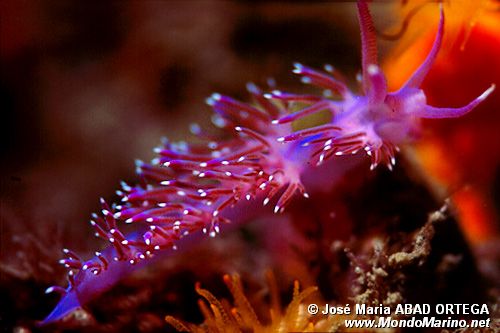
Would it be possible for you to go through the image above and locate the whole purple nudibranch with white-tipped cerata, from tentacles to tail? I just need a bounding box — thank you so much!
[42,1,494,324]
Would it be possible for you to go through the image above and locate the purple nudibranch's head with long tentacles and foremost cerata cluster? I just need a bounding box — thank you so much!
[272,1,495,169]
